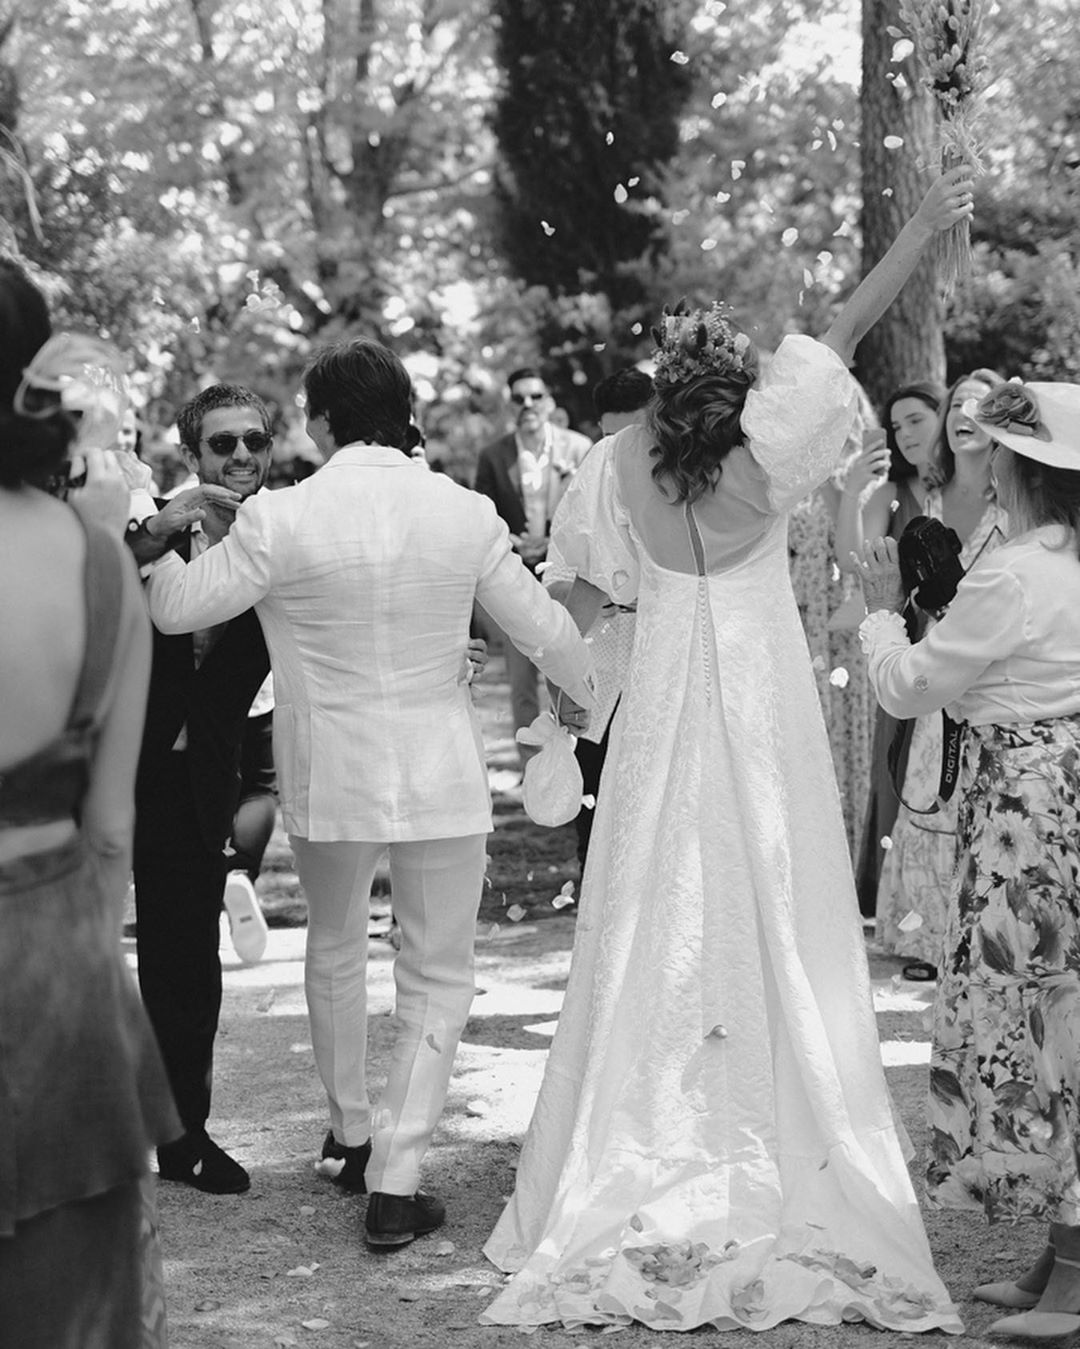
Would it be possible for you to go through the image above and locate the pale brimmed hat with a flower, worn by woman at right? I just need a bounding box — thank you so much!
[964,382,1080,471]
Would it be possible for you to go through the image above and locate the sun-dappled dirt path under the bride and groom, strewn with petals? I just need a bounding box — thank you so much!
[149,672,1019,1349]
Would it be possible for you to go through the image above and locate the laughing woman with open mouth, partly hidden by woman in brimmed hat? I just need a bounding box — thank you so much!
[875,370,1007,981]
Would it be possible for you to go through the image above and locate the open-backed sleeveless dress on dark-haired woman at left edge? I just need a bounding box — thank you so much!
[0,527,179,1349]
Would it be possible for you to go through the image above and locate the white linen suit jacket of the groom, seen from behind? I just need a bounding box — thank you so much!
[148,445,593,842]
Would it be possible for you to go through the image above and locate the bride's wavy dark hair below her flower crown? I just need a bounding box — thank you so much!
[649,347,758,502]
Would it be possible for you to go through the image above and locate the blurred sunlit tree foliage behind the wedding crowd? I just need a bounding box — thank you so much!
[0,0,1080,480]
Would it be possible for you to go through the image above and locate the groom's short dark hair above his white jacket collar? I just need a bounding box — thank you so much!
[303,337,413,449]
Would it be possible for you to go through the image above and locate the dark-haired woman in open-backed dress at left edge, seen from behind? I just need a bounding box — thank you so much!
[0,262,178,1349]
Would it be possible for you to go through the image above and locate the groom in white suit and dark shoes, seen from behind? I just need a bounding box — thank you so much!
[148,340,593,1248]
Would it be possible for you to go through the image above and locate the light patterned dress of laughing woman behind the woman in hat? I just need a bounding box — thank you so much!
[876,487,1009,966]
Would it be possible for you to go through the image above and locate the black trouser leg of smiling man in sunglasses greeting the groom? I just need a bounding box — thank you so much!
[135,753,225,1130]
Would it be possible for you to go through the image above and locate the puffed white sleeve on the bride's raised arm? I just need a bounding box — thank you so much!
[742,333,859,514]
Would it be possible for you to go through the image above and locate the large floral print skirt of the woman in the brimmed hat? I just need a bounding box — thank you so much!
[928,716,1080,1225]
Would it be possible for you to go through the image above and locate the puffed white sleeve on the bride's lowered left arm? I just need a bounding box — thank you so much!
[545,438,638,604]
